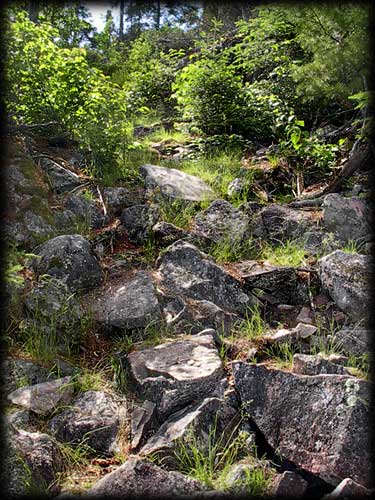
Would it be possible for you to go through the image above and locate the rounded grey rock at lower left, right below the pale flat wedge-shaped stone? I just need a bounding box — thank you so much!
[48,391,124,455]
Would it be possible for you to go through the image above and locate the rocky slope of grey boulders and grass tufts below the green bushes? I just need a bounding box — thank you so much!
[3,135,373,499]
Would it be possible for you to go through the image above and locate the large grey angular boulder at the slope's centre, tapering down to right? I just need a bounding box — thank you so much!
[157,241,256,313]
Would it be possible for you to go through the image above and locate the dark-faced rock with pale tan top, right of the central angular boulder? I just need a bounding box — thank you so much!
[233,260,309,305]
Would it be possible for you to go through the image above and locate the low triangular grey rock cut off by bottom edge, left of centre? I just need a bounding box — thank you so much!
[84,456,207,498]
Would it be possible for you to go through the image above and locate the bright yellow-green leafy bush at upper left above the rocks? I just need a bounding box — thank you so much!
[6,12,131,178]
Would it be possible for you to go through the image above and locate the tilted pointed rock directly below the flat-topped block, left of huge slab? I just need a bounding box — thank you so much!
[139,398,239,467]
